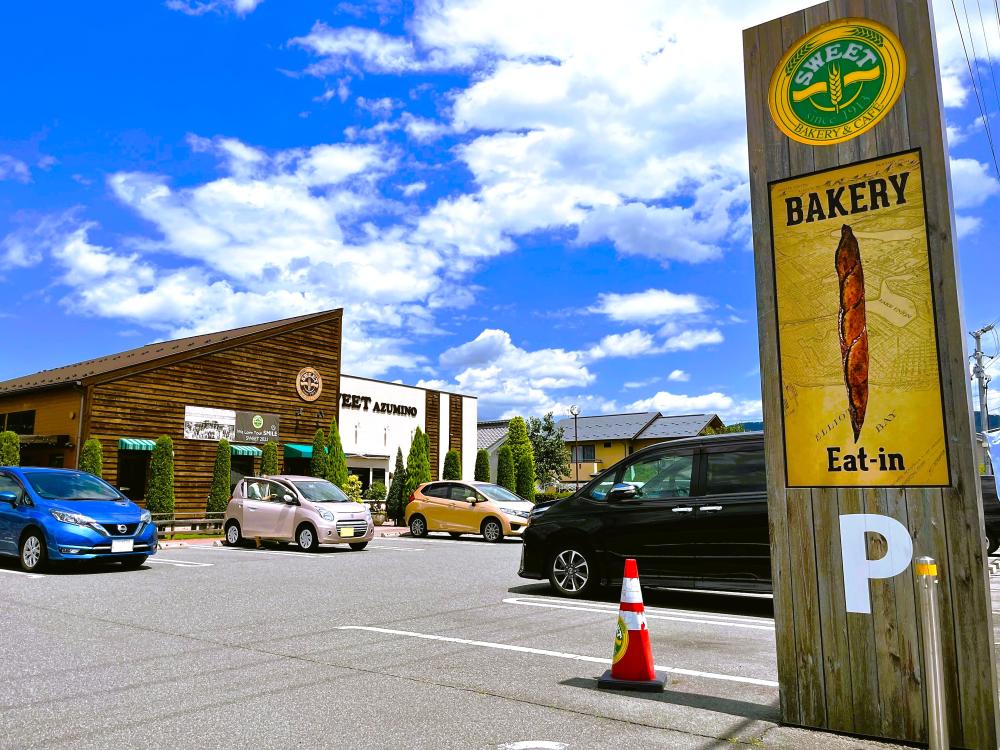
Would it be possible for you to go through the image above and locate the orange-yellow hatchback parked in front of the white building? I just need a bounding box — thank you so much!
[406,481,533,542]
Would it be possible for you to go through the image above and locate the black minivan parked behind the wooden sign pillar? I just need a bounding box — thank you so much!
[518,432,1000,597]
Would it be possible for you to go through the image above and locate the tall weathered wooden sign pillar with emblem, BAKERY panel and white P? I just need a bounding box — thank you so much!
[744,0,998,750]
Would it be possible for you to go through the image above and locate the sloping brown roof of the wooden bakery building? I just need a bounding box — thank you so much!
[0,309,343,395]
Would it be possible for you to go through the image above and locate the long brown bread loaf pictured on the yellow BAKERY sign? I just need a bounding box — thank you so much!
[835,224,868,443]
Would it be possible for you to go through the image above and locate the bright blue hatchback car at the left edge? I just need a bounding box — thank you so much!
[0,467,156,572]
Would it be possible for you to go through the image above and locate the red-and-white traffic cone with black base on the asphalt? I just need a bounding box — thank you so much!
[597,558,665,693]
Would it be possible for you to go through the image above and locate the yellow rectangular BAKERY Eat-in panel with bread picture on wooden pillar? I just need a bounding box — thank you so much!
[770,150,949,487]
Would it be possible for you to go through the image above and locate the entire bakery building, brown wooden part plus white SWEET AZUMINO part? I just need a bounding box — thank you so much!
[0,310,477,512]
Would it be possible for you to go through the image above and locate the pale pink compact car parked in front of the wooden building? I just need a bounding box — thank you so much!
[223,475,375,552]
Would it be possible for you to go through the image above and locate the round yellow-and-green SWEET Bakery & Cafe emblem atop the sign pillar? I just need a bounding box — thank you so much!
[767,18,906,146]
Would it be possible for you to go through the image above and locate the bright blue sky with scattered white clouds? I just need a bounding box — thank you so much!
[0,0,1000,421]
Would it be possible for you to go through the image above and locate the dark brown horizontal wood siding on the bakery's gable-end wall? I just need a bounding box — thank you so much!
[85,317,341,512]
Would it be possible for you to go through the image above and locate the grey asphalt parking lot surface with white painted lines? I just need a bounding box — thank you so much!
[0,536,992,750]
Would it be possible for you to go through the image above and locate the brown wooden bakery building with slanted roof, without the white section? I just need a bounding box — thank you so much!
[0,310,343,512]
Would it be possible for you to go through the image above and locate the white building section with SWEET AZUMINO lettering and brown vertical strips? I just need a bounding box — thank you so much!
[337,375,478,488]
